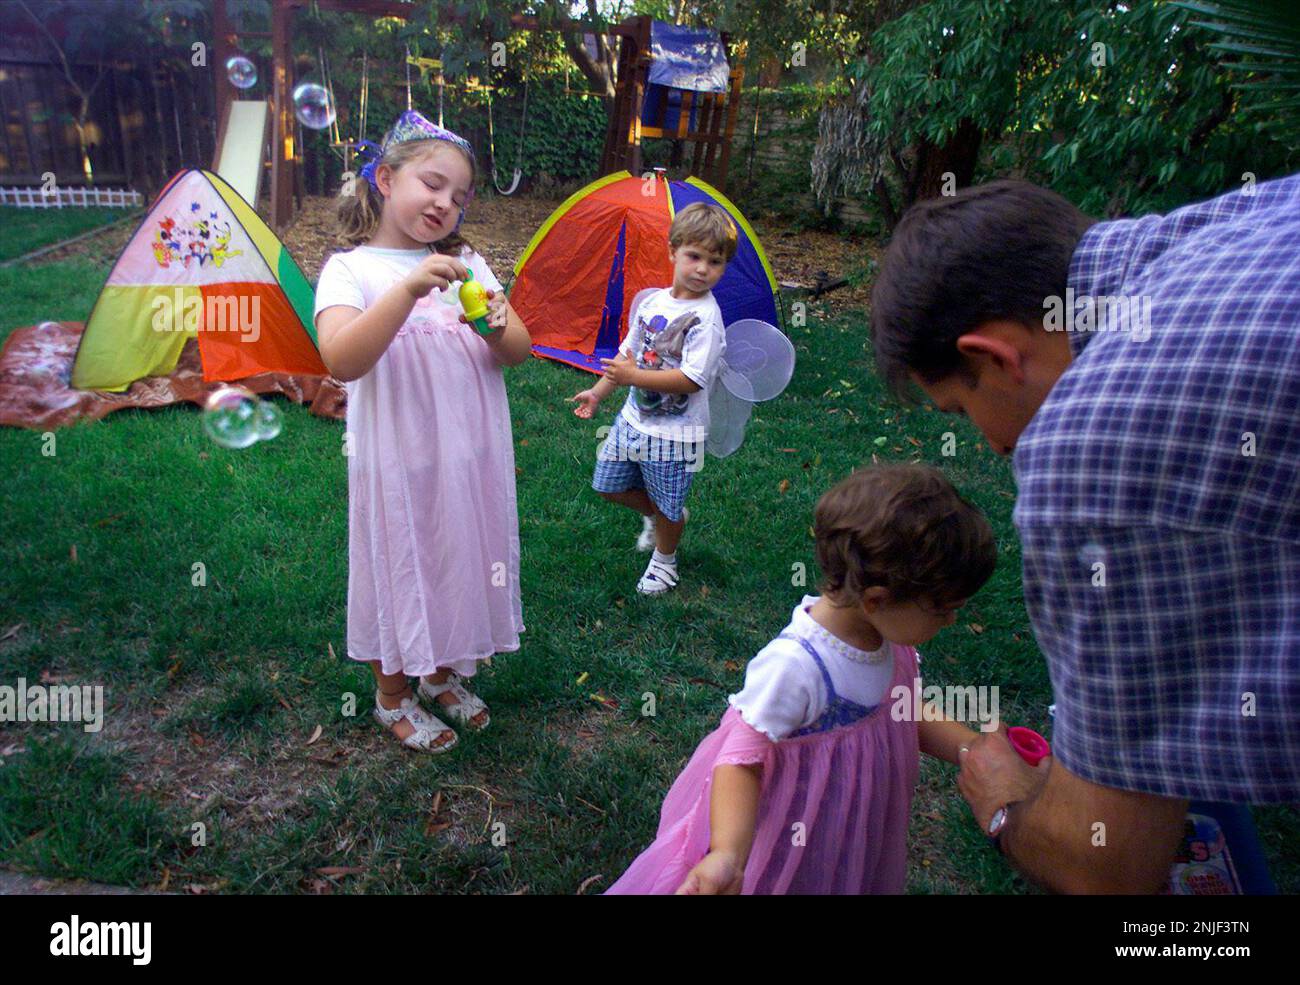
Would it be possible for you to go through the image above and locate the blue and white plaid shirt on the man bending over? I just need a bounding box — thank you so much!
[1013,175,1300,803]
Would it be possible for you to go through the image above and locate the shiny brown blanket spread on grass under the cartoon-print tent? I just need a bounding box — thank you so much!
[0,321,347,429]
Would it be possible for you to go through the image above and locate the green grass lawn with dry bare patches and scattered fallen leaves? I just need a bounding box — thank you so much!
[0,237,1300,893]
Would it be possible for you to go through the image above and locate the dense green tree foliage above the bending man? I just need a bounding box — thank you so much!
[819,0,1292,222]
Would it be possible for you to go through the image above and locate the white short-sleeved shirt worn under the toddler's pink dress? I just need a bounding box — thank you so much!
[727,595,919,742]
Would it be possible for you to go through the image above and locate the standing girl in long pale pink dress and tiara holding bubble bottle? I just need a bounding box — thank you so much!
[316,110,530,752]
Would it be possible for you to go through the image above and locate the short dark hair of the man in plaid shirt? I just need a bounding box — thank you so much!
[871,179,1096,403]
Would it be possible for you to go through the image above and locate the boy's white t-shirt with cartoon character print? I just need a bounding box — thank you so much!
[619,287,727,442]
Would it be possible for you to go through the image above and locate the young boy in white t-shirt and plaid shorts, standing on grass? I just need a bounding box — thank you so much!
[569,203,736,595]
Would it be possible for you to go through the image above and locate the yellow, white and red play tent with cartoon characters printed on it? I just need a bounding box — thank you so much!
[72,169,328,391]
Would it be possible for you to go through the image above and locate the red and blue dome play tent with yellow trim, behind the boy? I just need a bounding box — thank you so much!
[510,172,780,373]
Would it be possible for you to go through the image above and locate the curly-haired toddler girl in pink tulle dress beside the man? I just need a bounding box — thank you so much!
[608,465,997,894]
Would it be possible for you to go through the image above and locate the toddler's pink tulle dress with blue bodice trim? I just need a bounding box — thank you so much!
[607,633,920,894]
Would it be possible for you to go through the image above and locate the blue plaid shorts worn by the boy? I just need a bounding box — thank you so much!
[592,413,705,522]
